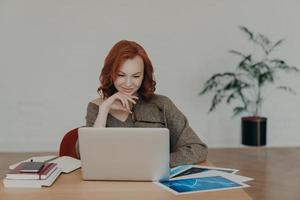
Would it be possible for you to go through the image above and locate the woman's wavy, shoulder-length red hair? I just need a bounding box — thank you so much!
[98,40,156,100]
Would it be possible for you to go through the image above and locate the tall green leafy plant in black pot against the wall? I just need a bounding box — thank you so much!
[199,26,299,146]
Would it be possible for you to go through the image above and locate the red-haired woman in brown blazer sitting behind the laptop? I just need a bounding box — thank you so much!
[86,40,207,167]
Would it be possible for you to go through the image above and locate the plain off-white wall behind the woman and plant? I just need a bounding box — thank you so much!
[0,0,300,151]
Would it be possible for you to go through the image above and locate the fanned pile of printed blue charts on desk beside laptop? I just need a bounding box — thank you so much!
[155,165,253,195]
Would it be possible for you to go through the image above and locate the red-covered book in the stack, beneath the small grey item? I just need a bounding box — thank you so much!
[6,162,57,180]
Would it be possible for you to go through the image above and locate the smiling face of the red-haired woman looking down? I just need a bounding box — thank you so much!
[114,56,144,95]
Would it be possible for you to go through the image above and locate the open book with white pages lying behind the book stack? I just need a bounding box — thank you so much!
[9,155,81,173]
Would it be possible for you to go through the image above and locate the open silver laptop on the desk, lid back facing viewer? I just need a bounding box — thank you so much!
[78,127,170,181]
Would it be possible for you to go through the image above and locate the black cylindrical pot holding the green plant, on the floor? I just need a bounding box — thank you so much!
[242,116,267,146]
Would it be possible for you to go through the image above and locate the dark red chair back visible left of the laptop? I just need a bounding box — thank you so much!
[59,127,80,159]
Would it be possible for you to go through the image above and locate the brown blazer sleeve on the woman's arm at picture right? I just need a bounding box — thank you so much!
[164,97,208,167]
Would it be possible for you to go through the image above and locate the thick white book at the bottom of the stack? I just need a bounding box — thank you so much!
[3,167,61,188]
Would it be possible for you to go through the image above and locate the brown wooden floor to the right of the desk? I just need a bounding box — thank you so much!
[208,147,300,200]
